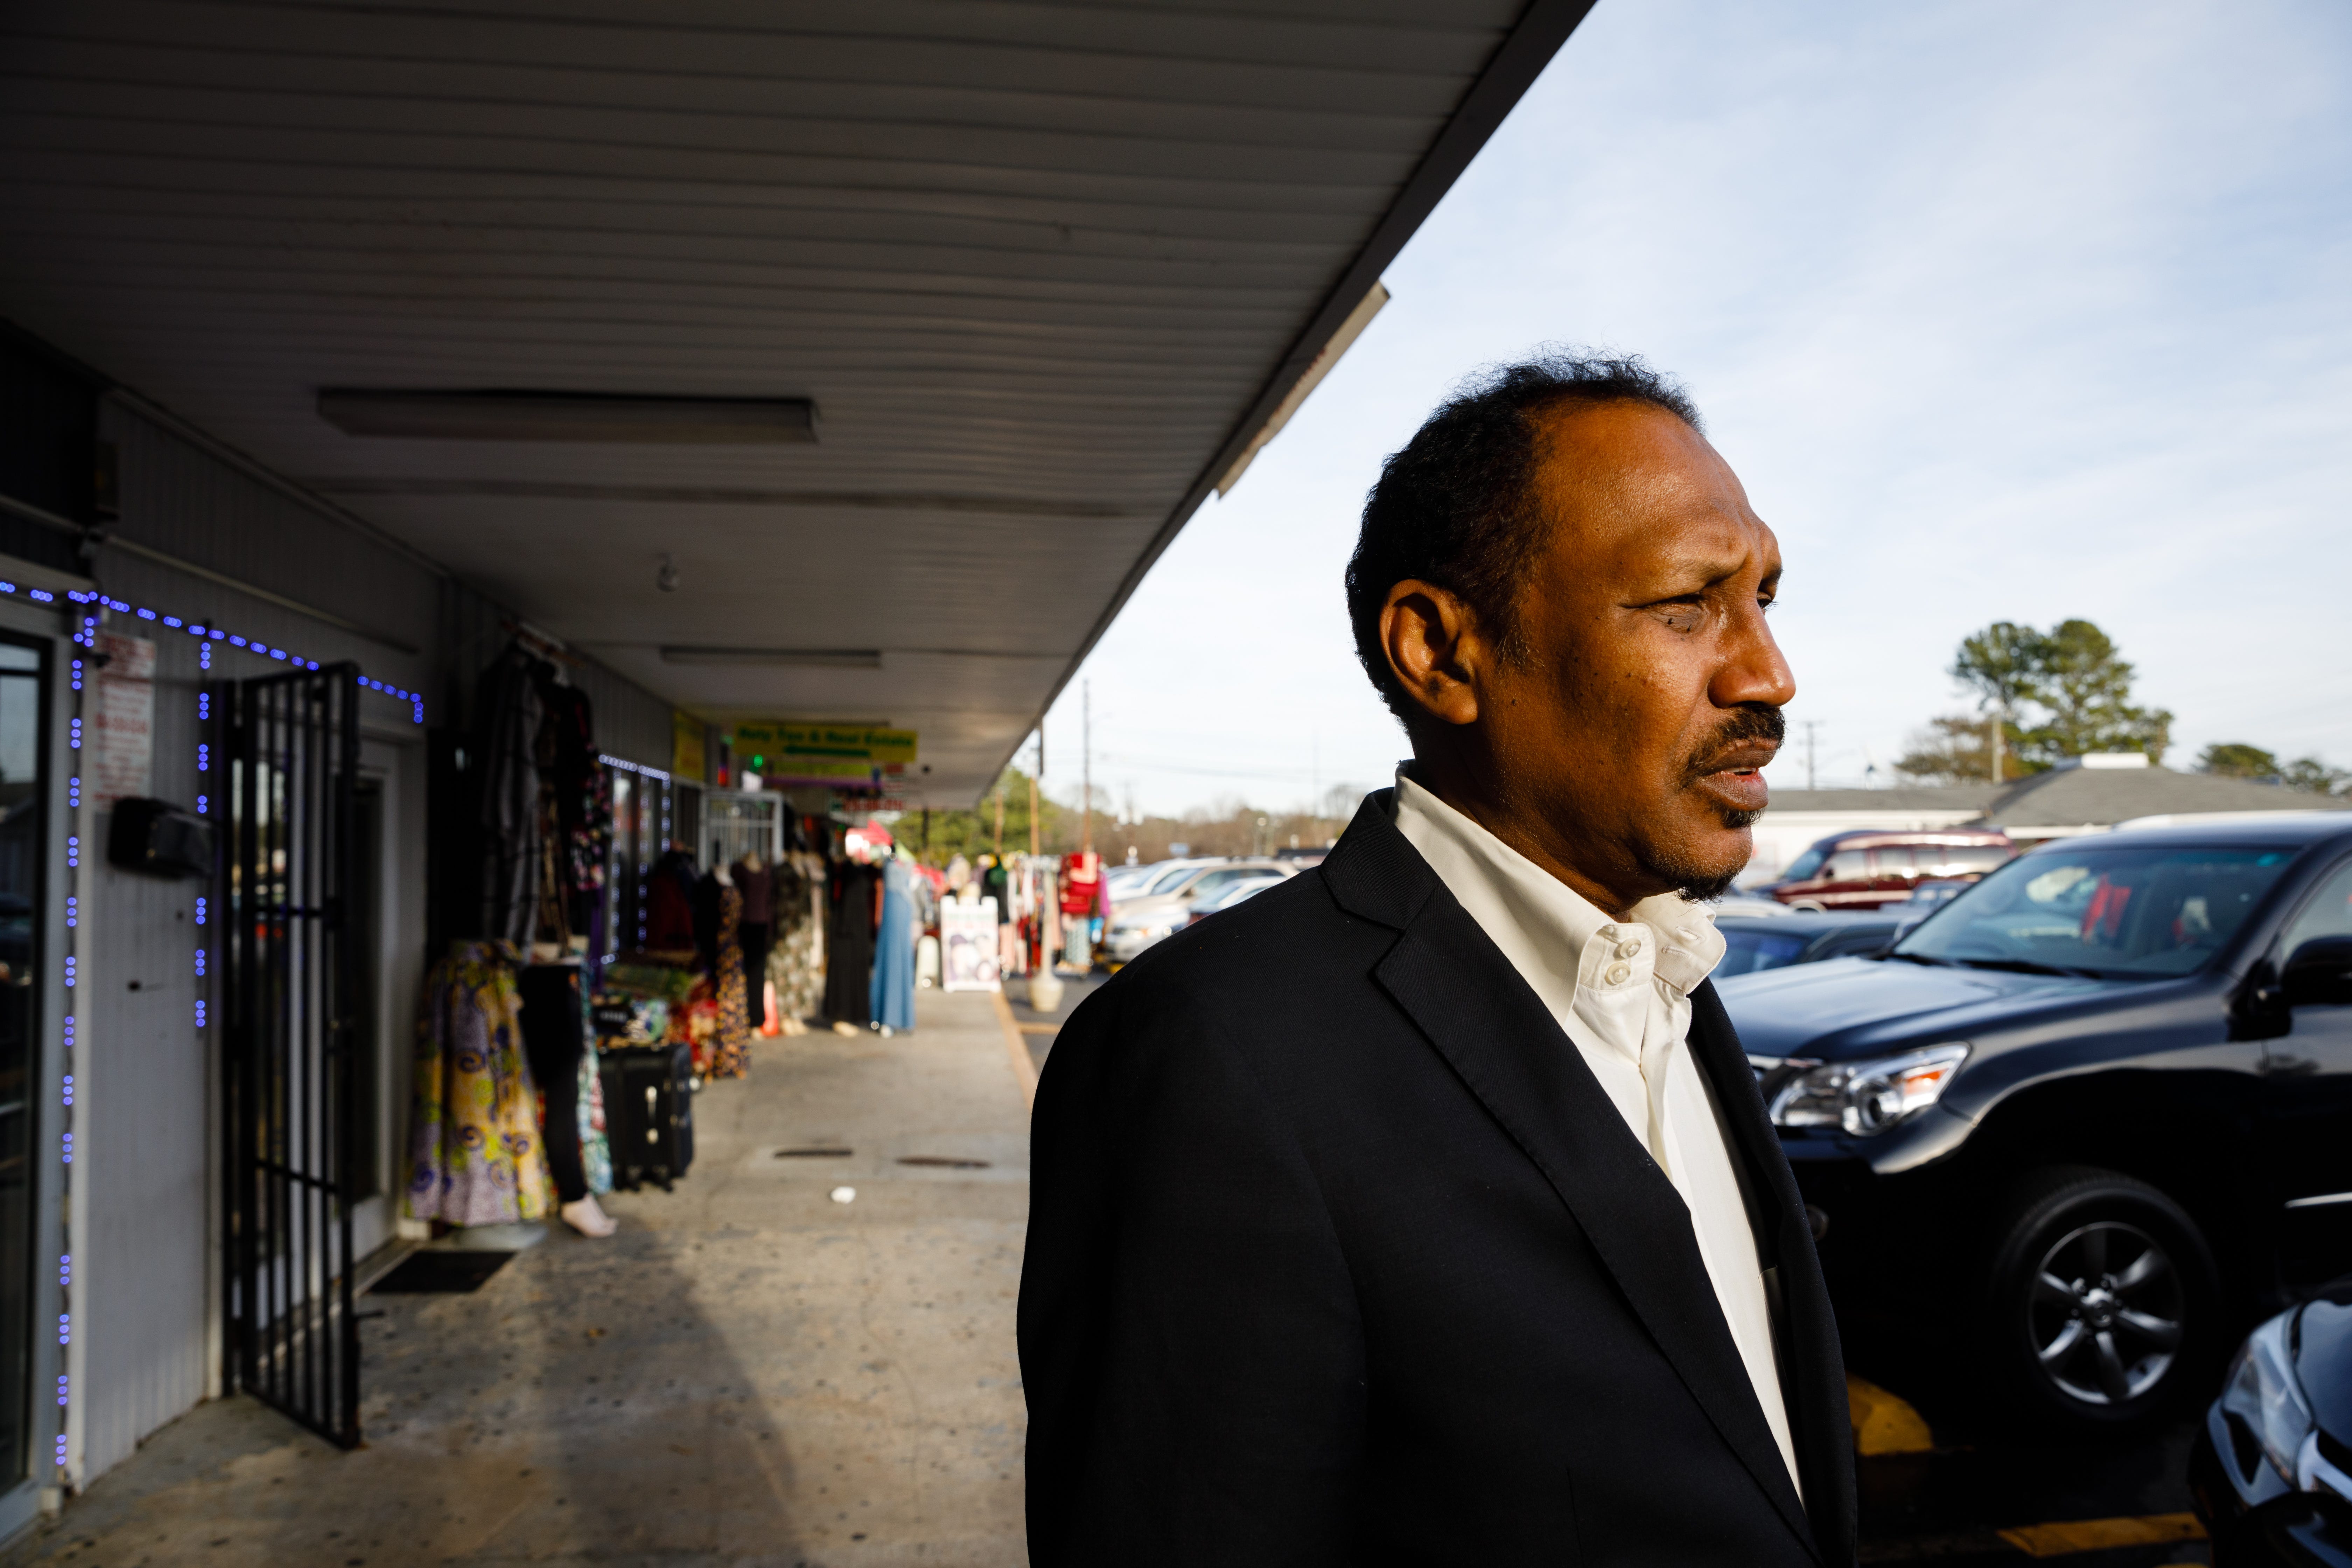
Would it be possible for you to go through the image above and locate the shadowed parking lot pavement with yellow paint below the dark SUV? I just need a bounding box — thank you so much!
[1856,1385,2213,1568]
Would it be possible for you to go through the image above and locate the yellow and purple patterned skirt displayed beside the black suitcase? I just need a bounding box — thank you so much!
[407,943,555,1225]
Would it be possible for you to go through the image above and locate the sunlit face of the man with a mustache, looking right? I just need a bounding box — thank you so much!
[1402,402,1797,905]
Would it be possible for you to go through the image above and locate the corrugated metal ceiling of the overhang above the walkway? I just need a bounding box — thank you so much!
[0,0,1590,804]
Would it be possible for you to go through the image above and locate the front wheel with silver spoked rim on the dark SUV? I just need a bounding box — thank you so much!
[1978,1168,2216,1429]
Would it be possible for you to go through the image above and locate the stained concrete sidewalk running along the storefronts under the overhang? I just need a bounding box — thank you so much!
[0,992,1028,1568]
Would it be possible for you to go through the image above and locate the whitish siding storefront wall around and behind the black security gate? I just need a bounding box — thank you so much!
[0,381,673,1504]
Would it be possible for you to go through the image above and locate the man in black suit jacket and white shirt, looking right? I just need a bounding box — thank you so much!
[1021,357,1853,1568]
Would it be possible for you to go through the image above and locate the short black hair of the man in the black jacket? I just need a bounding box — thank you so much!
[1348,350,1703,719]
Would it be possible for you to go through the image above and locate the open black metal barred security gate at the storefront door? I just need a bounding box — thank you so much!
[207,665,360,1448]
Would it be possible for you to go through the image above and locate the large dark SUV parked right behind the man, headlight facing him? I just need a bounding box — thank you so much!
[1724,813,2352,1427]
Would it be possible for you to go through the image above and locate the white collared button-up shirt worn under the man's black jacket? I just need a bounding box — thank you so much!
[1397,771,1804,1495]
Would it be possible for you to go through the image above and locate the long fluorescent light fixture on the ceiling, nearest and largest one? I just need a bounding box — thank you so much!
[317,388,816,447]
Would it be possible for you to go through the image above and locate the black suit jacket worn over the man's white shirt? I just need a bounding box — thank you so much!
[1021,792,1853,1568]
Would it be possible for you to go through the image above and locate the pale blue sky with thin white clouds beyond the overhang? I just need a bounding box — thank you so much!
[1046,0,2352,813]
